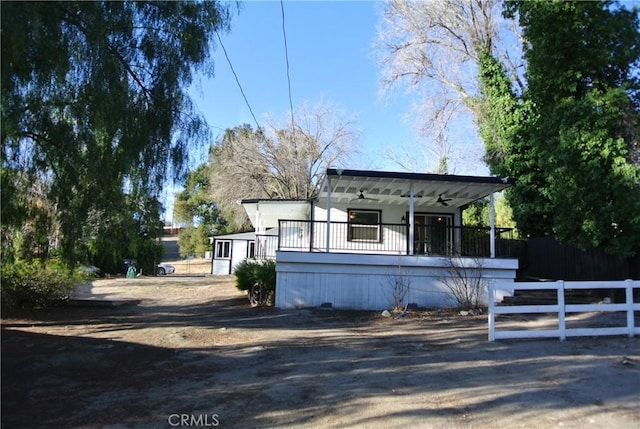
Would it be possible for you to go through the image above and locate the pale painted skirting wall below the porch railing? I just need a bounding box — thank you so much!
[275,252,518,310]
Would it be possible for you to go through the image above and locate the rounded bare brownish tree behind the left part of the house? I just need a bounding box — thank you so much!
[210,103,358,225]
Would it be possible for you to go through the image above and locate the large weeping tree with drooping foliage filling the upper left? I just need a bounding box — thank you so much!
[1,1,235,262]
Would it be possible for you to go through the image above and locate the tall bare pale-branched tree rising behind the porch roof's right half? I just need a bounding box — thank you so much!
[377,0,522,172]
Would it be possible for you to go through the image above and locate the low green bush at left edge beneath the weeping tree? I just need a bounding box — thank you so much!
[2,259,85,308]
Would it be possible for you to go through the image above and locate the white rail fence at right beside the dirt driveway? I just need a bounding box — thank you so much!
[488,280,640,341]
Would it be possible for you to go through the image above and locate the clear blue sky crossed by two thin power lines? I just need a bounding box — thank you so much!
[165,1,487,221]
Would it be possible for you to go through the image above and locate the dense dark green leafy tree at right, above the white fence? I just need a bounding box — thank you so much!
[477,1,640,256]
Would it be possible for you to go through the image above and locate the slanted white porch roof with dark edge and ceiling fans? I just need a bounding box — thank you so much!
[318,168,515,208]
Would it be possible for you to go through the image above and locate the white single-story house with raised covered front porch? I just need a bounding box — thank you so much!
[214,169,518,310]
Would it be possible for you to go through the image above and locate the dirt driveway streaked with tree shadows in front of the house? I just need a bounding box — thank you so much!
[2,276,640,429]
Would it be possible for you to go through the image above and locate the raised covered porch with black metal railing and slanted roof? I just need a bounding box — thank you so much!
[274,169,514,258]
